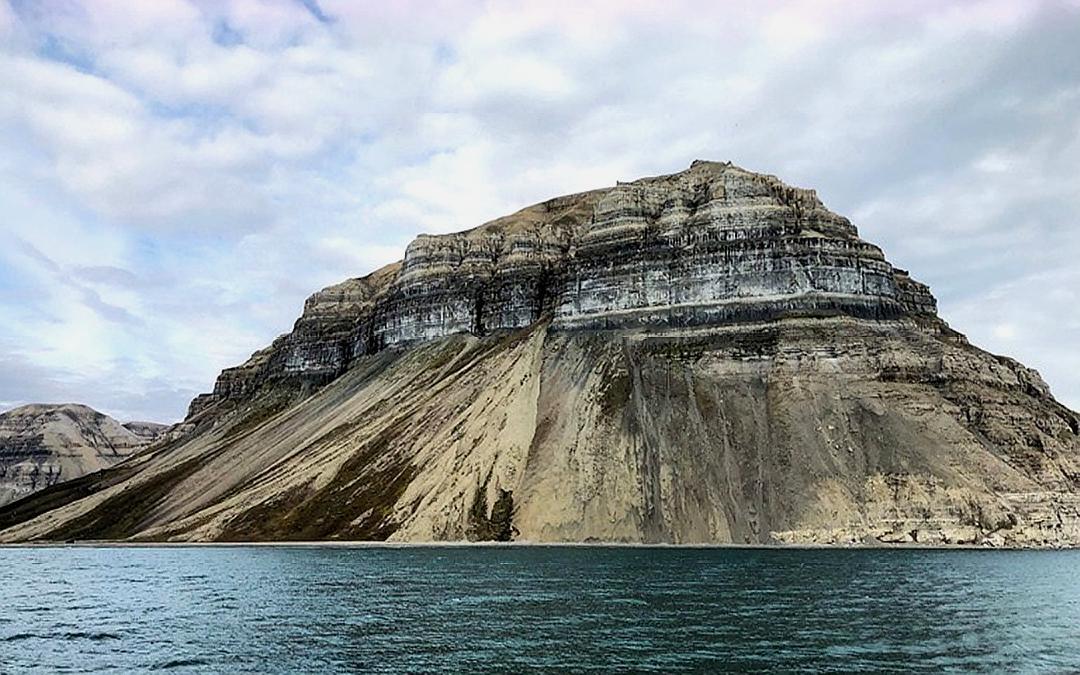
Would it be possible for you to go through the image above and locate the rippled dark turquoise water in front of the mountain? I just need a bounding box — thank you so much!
[0,548,1080,673]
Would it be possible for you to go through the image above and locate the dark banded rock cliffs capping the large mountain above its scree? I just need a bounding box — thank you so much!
[183,161,936,415]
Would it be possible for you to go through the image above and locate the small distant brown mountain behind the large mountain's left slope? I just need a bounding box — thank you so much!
[0,404,166,505]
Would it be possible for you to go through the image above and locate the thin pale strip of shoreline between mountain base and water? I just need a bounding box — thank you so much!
[0,540,1080,552]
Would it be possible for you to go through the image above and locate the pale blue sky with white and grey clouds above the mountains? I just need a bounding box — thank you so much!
[0,0,1080,421]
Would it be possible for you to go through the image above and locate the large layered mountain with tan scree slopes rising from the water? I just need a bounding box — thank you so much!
[0,162,1080,546]
